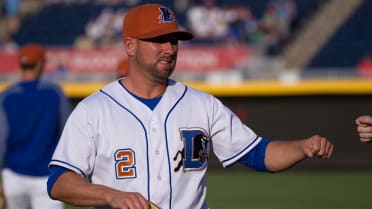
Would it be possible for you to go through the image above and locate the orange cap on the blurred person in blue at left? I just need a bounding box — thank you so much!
[19,44,45,64]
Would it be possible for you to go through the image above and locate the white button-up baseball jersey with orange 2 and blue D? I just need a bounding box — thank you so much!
[51,80,261,209]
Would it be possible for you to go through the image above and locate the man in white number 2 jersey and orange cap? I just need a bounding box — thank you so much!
[48,4,333,209]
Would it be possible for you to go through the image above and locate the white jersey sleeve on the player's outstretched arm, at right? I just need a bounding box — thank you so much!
[211,98,262,167]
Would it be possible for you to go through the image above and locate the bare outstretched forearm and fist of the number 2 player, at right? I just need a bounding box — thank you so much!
[265,135,333,172]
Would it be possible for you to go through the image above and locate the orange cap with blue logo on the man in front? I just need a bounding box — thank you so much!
[123,4,193,40]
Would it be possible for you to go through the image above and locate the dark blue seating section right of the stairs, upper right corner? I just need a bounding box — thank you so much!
[307,0,372,70]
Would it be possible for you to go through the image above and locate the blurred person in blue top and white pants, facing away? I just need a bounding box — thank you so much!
[0,44,72,209]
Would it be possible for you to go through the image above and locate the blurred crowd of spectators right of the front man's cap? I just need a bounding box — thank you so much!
[186,0,296,55]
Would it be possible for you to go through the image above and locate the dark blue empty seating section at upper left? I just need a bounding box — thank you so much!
[13,3,113,46]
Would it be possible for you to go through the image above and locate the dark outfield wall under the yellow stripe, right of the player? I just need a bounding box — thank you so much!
[221,95,372,169]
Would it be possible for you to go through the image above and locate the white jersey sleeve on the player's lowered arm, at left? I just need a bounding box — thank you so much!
[49,103,97,177]
